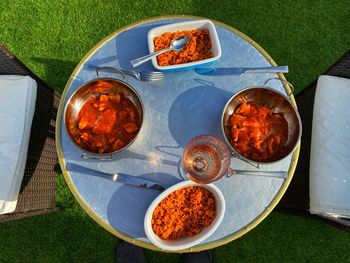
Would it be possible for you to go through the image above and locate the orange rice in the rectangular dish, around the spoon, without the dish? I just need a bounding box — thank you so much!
[154,29,214,66]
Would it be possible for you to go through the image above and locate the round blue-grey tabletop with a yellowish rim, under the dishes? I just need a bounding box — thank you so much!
[56,16,300,252]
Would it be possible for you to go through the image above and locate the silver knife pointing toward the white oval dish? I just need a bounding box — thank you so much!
[66,162,165,192]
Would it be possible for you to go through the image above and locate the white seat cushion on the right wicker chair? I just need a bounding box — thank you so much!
[310,76,350,218]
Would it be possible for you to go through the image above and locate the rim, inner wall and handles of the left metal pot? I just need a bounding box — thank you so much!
[64,67,144,160]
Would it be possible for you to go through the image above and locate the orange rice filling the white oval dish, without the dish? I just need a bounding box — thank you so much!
[152,186,216,240]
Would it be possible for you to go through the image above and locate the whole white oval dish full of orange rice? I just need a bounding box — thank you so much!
[144,181,225,250]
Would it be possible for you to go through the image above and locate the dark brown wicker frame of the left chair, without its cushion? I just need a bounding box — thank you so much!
[0,43,61,222]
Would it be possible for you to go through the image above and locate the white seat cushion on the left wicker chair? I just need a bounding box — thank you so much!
[0,75,37,214]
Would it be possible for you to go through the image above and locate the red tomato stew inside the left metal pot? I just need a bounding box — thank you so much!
[69,93,140,153]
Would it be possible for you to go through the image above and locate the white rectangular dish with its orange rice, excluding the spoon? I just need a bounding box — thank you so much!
[147,20,221,71]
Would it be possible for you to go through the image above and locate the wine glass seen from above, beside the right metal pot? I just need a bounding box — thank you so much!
[180,135,231,184]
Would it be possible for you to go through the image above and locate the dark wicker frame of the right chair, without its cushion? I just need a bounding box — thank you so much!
[277,51,350,231]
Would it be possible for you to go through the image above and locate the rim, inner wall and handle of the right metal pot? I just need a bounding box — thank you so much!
[221,78,302,167]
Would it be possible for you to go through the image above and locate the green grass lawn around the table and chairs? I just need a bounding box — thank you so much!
[0,0,350,262]
